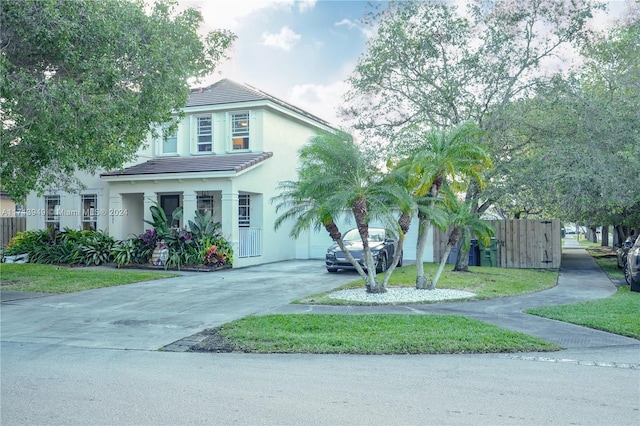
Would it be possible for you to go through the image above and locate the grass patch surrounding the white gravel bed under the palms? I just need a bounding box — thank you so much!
[294,263,558,305]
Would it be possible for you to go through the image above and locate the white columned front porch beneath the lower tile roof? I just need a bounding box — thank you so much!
[102,153,268,267]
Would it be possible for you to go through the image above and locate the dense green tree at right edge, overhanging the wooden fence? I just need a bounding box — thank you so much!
[484,15,640,239]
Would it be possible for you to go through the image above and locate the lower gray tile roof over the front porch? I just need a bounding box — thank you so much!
[100,152,273,176]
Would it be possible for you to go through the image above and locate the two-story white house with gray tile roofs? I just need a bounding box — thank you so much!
[27,79,436,267]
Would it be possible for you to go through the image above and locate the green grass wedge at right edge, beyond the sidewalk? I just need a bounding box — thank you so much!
[526,287,640,339]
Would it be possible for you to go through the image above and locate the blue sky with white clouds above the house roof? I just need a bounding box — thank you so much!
[179,0,625,125]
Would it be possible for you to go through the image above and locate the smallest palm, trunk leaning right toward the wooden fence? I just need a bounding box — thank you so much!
[428,188,495,290]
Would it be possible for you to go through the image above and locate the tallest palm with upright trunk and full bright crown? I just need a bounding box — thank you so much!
[399,122,492,289]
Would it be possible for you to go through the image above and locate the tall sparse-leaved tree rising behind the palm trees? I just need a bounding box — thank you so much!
[344,0,598,269]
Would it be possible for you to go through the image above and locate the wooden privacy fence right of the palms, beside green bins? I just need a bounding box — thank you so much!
[433,219,562,269]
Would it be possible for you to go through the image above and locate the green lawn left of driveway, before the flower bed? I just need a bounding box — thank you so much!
[0,263,178,293]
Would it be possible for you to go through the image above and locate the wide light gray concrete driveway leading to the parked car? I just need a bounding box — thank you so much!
[0,260,358,350]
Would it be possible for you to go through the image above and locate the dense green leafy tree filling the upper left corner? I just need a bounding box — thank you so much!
[0,0,235,199]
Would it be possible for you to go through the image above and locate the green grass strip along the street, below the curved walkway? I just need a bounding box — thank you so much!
[191,314,562,355]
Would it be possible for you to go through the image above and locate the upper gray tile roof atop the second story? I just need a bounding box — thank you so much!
[187,78,331,127]
